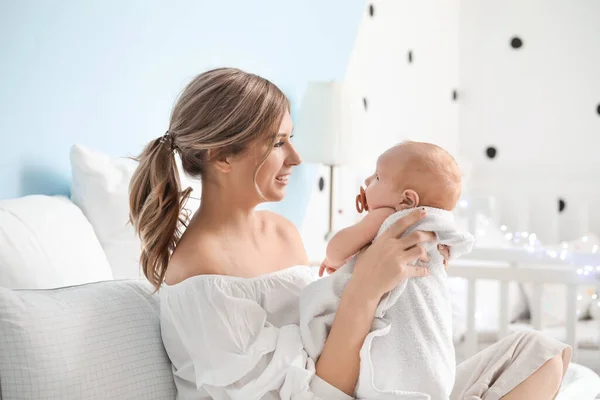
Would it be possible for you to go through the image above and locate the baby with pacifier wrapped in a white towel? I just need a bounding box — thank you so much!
[300,142,473,400]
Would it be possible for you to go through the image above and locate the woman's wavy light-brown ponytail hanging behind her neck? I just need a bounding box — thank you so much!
[129,134,192,290]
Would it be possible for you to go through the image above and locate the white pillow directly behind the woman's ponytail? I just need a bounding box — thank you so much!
[71,145,200,279]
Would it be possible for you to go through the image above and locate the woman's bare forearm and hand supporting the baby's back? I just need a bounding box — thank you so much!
[316,211,435,395]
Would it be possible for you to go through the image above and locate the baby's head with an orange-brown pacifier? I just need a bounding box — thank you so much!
[357,142,461,211]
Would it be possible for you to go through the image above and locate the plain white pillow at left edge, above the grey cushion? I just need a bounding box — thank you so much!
[0,195,112,289]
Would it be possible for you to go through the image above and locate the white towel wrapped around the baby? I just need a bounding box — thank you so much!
[300,208,473,399]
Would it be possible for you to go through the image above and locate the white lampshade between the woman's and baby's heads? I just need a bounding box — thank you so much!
[294,82,367,165]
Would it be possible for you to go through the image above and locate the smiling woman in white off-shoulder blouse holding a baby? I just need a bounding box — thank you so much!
[130,68,570,400]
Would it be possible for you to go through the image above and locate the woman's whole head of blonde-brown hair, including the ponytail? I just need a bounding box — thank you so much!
[129,68,290,290]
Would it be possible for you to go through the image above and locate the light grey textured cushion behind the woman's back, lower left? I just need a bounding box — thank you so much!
[0,280,176,400]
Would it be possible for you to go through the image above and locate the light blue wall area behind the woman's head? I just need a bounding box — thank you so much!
[0,0,366,228]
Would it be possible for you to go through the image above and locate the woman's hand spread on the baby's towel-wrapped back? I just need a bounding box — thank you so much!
[348,209,436,302]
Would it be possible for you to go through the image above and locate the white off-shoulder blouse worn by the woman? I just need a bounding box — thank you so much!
[159,266,351,400]
